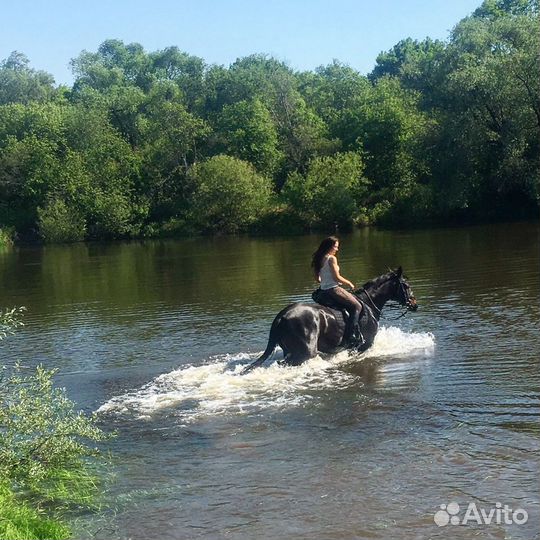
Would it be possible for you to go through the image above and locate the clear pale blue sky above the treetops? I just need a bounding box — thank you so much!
[0,0,481,84]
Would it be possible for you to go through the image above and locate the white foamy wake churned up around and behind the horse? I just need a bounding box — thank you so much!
[98,327,434,422]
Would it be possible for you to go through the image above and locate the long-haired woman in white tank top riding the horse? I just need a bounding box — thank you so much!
[311,236,362,346]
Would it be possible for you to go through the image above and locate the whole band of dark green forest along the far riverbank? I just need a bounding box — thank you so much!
[0,0,540,242]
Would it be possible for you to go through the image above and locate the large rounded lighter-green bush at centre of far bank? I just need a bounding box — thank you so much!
[189,155,271,233]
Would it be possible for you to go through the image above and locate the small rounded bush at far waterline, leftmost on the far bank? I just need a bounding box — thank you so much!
[37,199,86,243]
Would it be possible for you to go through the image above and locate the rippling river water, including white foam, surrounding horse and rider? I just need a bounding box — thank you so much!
[0,223,540,540]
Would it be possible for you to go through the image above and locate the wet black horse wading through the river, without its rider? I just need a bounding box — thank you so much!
[242,266,418,373]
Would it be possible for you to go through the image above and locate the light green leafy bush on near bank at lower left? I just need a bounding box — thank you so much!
[0,367,105,505]
